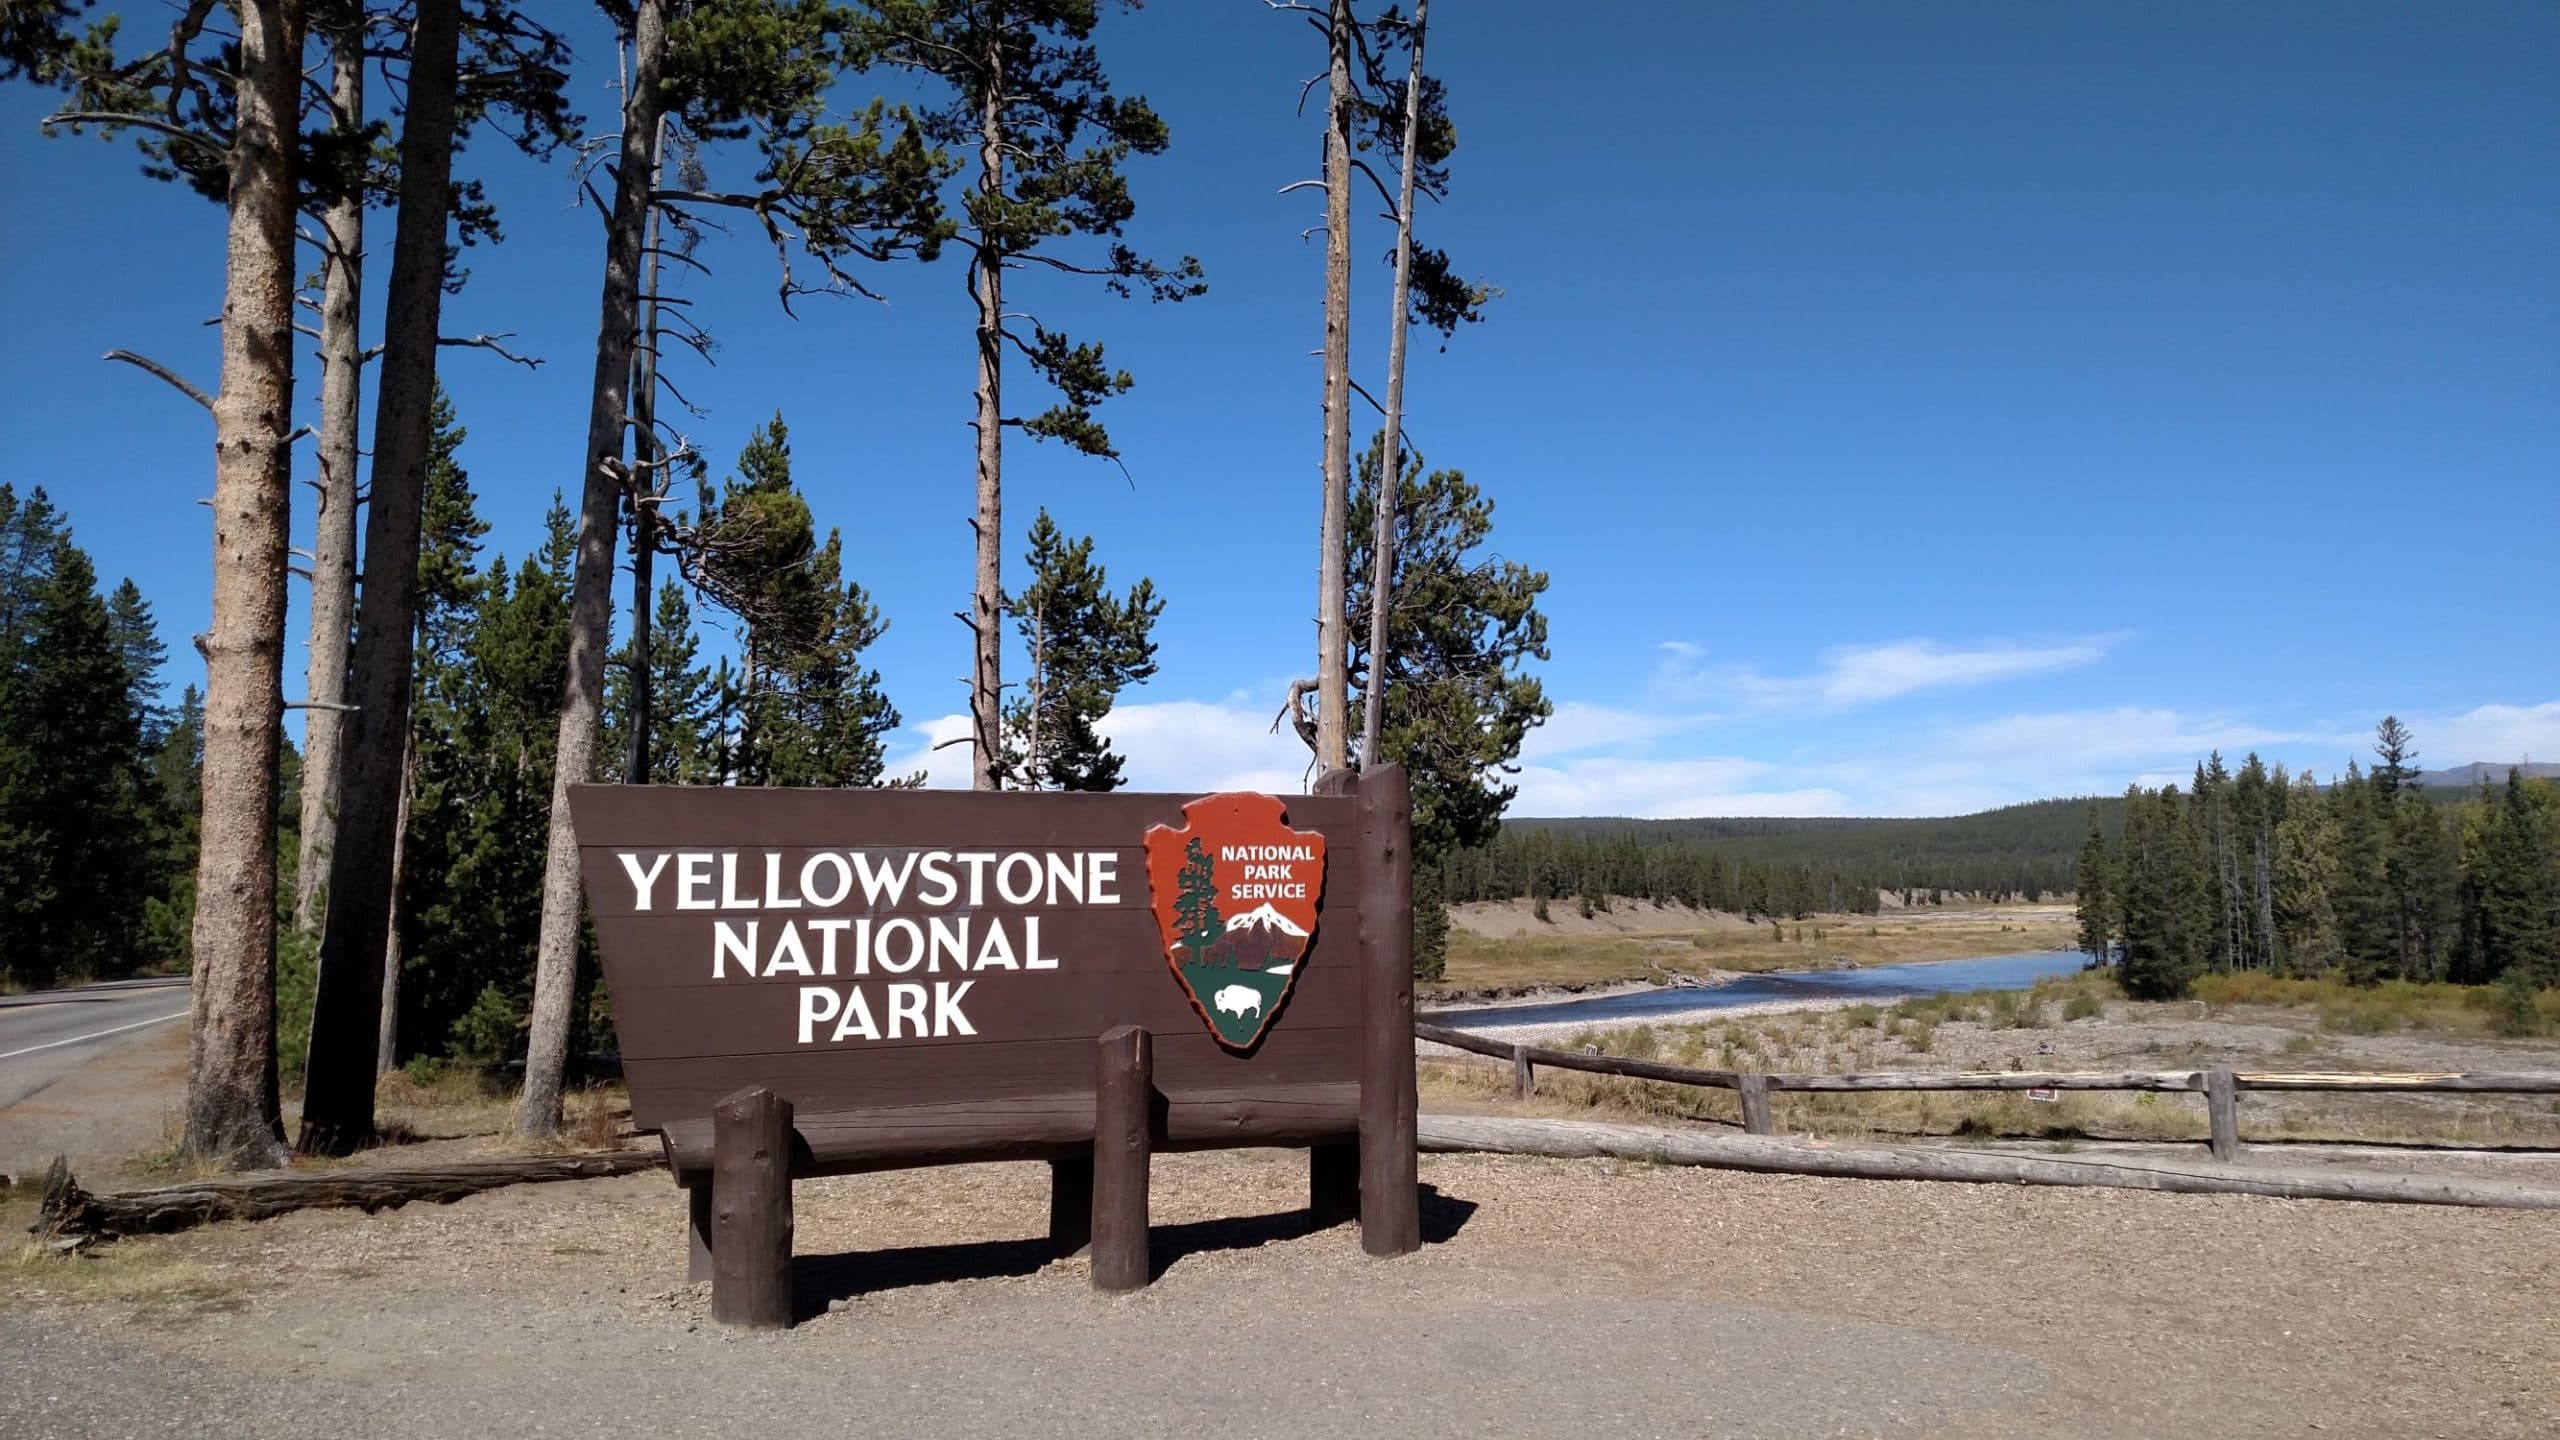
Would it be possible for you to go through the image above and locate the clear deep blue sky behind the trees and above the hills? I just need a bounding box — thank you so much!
[0,0,2560,815]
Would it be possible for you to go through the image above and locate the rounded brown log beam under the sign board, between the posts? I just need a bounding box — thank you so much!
[663,1076,1359,1176]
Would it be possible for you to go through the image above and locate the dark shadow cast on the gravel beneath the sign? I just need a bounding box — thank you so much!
[791,1184,1477,1320]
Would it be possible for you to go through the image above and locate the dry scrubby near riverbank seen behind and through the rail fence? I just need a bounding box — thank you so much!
[1423,971,2560,1147]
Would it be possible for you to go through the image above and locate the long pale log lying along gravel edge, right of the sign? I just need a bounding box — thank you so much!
[1418,1115,2560,1209]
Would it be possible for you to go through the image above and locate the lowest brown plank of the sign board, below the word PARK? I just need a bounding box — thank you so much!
[622,1017,1359,1130]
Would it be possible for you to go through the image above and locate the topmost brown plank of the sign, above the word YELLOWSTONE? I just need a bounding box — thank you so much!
[568,784,1352,851]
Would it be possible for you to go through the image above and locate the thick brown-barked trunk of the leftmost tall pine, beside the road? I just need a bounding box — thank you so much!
[184,0,302,1166]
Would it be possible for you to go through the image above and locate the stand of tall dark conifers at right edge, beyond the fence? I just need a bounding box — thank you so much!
[2079,717,2560,997]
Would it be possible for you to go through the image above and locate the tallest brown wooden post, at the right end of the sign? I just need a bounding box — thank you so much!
[1354,766,1423,1256]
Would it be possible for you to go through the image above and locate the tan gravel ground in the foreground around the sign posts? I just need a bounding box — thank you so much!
[0,1137,2560,1440]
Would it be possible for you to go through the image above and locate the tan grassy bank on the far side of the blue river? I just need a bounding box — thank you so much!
[1418,899,2076,1004]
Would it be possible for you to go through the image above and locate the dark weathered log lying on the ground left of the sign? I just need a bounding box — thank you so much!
[31,1148,666,1238]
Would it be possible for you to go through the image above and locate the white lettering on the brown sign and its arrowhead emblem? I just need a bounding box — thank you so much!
[614,846,1111,1045]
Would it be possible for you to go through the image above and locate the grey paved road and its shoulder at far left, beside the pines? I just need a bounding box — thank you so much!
[0,976,187,1171]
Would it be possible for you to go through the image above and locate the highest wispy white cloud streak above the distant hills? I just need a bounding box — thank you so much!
[1654,635,2117,712]
